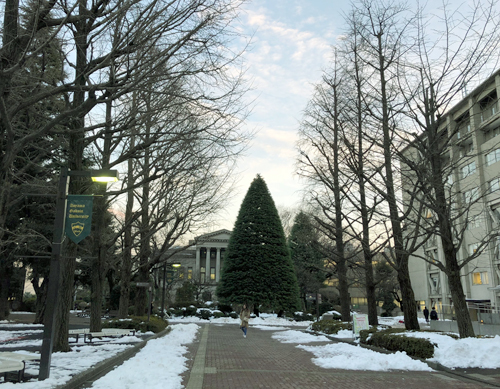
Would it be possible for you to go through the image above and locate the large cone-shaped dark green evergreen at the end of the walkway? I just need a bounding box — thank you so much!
[217,175,299,311]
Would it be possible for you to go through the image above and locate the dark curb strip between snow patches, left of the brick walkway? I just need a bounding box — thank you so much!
[54,327,170,389]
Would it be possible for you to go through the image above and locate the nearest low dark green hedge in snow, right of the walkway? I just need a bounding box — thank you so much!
[360,328,435,359]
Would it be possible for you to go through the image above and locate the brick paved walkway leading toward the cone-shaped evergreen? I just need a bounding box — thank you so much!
[183,324,491,389]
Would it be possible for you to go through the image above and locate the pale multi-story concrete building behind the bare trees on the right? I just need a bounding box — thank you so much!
[408,70,500,319]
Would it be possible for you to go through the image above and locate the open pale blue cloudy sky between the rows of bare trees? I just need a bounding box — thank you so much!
[220,0,350,229]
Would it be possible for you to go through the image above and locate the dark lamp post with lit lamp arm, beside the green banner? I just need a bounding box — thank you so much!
[38,167,118,381]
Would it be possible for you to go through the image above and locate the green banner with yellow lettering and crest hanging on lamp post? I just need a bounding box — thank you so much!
[65,195,94,243]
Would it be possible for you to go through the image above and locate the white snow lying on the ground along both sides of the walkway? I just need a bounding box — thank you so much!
[0,314,500,389]
